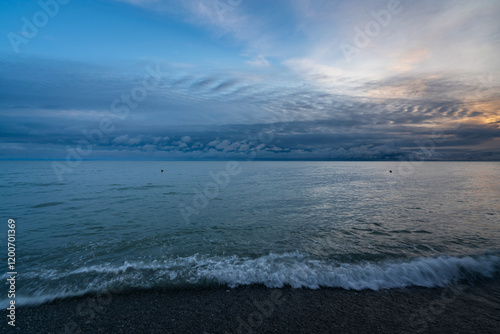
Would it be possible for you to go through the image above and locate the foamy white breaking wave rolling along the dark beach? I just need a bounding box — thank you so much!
[0,252,500,307]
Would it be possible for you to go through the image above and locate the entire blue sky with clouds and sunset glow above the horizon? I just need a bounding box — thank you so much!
[0,0,500,163]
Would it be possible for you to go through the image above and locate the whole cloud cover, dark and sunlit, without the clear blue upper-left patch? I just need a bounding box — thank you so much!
[0,0,500,159]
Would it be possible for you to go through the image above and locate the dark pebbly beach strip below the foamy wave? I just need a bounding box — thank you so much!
[0,279,500,334]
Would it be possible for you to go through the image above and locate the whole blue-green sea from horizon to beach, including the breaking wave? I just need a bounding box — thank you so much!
[0,161,500,307]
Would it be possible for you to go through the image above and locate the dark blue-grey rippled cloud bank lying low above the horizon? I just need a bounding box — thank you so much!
[0,54,500,159]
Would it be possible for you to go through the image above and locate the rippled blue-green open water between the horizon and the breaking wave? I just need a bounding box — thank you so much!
[0,162,500,304]
